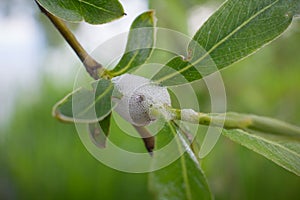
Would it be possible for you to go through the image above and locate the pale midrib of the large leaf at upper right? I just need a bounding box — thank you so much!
[156,0,279,82]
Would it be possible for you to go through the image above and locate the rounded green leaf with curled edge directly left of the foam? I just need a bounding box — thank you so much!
[53,79,114,123]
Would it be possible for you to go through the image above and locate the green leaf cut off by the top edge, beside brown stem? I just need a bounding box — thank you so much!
[37,0,124,24]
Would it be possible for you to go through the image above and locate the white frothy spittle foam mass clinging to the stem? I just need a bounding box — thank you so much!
[112,74,171,126]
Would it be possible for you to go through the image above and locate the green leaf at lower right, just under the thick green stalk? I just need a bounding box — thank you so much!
[223,129,300,176]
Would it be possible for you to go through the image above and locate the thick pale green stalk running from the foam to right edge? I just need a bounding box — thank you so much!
[168,108,300,138]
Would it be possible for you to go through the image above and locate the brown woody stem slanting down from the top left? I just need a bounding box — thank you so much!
[35,1,106,80]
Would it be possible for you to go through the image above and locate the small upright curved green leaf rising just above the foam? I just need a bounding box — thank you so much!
[111,11,155,76]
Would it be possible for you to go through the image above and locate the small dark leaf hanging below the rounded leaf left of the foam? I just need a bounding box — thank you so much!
[88,113,111,148]
